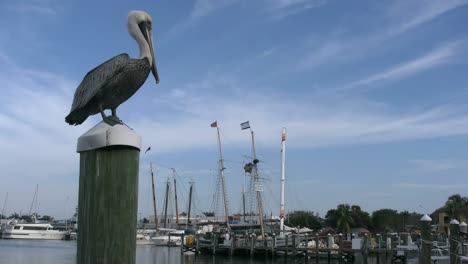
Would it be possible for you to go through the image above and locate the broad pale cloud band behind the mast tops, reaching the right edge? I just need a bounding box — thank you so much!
[128,75,468,152]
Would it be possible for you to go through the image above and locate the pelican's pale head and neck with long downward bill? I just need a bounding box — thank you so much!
[127,10,159,83]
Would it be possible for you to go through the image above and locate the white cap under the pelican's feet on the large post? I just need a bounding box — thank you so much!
[76,121,141,152]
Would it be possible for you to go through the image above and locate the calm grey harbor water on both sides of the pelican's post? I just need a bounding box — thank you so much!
[0,239,424,264]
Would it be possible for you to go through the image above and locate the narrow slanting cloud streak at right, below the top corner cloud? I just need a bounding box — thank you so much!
[342,40,466,90]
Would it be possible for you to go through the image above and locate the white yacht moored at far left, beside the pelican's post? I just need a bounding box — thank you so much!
[2,220,68,240]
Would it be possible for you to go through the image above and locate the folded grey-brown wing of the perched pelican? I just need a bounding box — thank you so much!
[70,53,130,112]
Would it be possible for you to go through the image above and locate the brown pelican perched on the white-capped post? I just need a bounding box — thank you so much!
[65,11,159,126]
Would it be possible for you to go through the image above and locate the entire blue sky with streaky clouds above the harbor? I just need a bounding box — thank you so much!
[0,0,468,218]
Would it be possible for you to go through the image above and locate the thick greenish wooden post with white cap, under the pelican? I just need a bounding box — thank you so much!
[77,122,141,264]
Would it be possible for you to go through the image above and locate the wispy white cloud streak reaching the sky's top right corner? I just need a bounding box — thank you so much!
[298,0,468,69]
